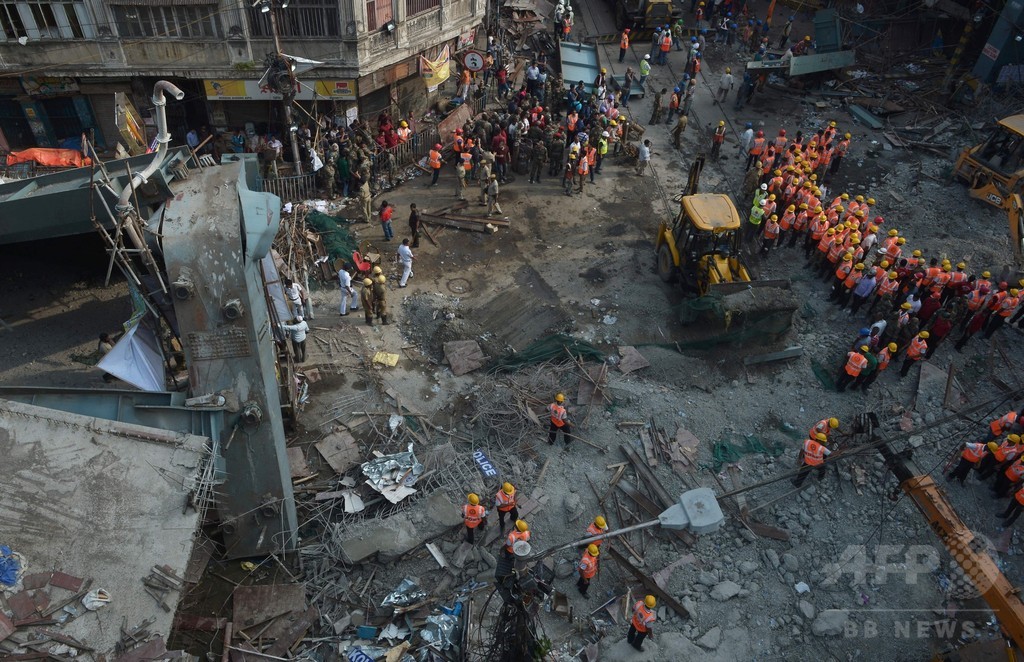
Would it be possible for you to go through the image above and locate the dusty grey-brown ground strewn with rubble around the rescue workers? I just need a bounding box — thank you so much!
[0,10,1024,660]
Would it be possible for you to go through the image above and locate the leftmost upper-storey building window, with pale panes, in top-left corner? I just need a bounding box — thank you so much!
[0,0,95,40]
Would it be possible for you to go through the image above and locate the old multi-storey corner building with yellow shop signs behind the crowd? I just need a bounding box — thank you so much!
[0,0,485,151]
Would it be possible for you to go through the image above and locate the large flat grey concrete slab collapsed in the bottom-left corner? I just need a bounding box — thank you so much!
[0,400,209,653]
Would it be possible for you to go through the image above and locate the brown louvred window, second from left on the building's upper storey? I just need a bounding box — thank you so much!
[112,4,223,39]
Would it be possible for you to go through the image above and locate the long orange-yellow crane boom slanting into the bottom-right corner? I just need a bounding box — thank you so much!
[879,444,1024,651]
